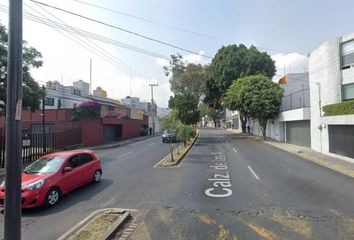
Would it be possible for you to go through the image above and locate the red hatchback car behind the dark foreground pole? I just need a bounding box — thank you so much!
[0,150,102,208]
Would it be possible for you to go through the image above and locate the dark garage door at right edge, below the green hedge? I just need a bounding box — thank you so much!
[328,125,354,158]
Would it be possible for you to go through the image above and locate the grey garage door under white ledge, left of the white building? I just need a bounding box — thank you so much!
[286,120,311,147]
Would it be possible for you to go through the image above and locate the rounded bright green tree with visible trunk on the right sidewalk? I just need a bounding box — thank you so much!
[225,75,284,140]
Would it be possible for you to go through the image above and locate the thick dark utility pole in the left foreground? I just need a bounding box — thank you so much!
[4,0,22,240]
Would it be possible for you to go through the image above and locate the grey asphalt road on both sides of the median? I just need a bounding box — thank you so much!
[0,129,354,240]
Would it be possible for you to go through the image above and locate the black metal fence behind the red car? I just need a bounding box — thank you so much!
[0,129,81,168]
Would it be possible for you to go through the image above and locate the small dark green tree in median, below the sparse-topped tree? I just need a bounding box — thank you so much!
[168,93,200,125]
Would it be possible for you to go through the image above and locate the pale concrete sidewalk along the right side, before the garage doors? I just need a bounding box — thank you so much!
[264,140,354,178]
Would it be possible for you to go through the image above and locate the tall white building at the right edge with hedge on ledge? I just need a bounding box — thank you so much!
[309,33,354,158]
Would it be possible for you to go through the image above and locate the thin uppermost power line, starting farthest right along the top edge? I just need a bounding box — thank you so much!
[72,0,223,40]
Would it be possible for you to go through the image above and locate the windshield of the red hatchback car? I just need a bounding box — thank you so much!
[23,156,65,174]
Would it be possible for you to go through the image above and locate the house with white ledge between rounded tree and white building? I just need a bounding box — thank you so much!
[251,73,311,147]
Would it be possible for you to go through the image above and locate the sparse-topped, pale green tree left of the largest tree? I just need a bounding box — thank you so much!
[164,54,207,98]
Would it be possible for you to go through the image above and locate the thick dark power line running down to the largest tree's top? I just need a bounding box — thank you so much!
[31,0,213,59]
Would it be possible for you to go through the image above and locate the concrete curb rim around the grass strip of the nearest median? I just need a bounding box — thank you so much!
[58,208,130,240]
